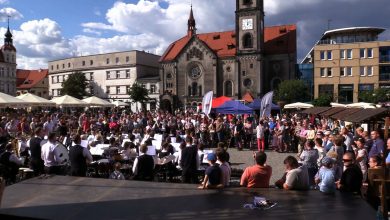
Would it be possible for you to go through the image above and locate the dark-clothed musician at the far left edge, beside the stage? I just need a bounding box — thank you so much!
[0,143,22,183]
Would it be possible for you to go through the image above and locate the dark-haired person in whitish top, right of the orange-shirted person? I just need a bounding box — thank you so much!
[283,156,310,190]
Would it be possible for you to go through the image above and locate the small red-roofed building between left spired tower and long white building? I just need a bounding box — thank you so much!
[16,69,49,99]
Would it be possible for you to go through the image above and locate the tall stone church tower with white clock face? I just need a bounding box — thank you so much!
[236,0,264,98]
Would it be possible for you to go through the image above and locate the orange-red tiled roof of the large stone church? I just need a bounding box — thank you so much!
[160,25,296,62]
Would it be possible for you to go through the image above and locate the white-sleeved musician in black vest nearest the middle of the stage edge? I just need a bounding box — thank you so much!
[133,144,155,181]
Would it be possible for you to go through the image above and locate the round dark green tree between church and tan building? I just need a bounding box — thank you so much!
[275,80,310,103]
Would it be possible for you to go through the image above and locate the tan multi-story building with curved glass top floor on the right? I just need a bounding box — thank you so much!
[303,27,390,103]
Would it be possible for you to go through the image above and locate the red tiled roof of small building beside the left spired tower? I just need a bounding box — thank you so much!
[16,69,49,89]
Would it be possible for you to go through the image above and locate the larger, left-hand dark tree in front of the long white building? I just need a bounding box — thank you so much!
[61,72,89,99]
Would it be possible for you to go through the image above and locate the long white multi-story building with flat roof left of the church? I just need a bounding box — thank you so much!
[49,50,160,111]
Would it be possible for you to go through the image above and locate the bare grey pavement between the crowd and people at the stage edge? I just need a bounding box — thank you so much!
[221,148,296,185]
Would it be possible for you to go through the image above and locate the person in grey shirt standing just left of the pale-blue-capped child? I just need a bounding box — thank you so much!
[300,140,319,186]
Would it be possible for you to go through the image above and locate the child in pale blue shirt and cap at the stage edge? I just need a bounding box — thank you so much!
[315,157,336,194]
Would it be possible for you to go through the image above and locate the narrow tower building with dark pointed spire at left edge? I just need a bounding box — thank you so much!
[0,24,16,96]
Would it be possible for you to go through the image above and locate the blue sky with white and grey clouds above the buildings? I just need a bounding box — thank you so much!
[0,0,390,68]
